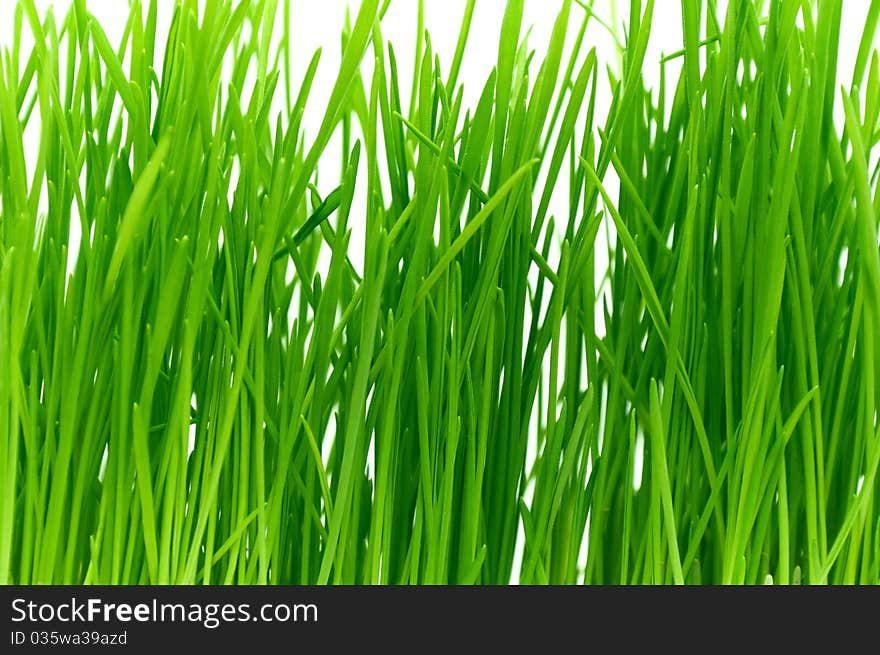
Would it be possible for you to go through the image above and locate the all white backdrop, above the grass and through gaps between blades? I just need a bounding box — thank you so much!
[0,0,868,584]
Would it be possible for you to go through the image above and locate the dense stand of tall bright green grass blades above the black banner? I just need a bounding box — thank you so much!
[0,0,880,584]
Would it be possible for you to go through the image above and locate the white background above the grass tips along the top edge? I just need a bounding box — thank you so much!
[0,0,869,128]
